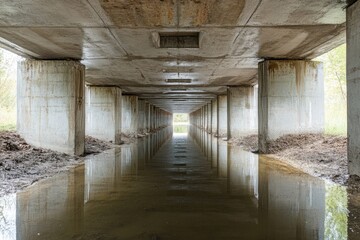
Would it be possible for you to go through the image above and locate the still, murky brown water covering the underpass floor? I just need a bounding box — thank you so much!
[0,129,360,240]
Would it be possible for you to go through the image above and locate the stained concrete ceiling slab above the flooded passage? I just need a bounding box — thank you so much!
[0,0,346,112]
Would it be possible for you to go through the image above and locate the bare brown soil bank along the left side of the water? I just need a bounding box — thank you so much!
[0,131,112,196]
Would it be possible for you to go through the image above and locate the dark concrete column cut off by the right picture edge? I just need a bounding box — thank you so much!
[346,1,360,176]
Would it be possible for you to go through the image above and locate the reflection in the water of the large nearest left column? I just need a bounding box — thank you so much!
[16,167,84,240]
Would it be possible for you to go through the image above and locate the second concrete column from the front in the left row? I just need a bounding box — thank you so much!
[86,86,122,144]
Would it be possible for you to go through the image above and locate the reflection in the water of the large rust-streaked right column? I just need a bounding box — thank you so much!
[259,158,325,239]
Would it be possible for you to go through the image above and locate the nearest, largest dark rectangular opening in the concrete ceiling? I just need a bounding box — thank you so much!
[159,32,199,48]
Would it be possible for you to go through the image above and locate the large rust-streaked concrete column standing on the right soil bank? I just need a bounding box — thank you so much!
[259,60,324,153]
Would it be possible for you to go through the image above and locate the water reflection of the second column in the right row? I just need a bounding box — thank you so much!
[228,147,259,198]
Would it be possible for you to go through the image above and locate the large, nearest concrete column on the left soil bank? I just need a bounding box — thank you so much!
[17,60,85,155]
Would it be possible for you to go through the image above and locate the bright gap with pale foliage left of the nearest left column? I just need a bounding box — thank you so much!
[0,48,21,131]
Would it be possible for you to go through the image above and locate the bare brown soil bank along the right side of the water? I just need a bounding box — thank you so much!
[229,134,360,192]
